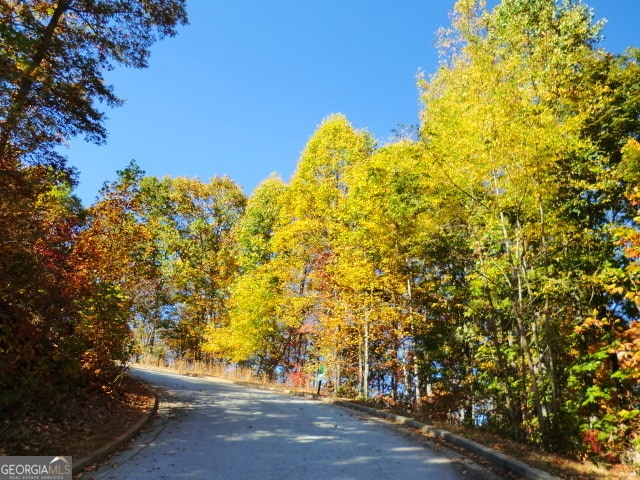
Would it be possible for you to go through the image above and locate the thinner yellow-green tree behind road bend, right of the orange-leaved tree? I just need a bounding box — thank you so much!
[143,177,246,359]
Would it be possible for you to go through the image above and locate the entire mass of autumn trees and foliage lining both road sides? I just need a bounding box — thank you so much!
[0,0,640,471]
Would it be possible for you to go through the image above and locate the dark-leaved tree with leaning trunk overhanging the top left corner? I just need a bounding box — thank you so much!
[0,0,187,170]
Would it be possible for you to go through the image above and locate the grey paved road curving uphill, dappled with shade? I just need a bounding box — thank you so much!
[87,368,490,480]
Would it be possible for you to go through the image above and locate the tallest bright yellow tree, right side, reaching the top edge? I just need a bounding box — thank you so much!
[421,0,637,450]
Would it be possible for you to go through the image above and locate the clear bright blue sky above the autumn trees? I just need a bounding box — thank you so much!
[63,0,640,206]
